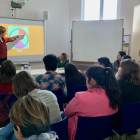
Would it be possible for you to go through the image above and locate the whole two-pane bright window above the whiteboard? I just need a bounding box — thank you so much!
[82,0,118,20]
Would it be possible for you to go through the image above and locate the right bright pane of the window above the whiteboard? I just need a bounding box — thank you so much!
[103,0,118,20]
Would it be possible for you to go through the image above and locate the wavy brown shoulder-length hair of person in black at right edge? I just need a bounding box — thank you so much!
[120,59,140,86]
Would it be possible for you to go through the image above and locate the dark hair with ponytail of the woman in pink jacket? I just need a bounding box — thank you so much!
[86,65,121,109]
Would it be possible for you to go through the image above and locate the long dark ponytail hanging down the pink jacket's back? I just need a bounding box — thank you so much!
[104,68,121,109]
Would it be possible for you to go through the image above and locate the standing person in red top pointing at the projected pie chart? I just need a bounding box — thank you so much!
[0,26,20,65]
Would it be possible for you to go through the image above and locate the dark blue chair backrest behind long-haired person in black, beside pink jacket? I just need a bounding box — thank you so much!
[69,85,87,101]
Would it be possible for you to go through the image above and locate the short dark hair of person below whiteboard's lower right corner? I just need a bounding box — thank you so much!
[98,57,113,70]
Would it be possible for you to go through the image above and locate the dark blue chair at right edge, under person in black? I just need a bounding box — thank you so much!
[113,102,140,139]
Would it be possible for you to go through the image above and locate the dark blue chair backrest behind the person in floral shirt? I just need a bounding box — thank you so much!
[52,90,64,111]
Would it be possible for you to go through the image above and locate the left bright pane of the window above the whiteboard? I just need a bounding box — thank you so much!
[84,0,100,20]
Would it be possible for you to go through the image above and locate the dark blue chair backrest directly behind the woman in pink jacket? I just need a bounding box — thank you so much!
[75,115,112,140]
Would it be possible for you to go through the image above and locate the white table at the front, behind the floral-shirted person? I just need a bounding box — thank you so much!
[16,68,65,76]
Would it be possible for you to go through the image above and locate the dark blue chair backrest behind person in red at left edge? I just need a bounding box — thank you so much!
[0,93,17,108]
